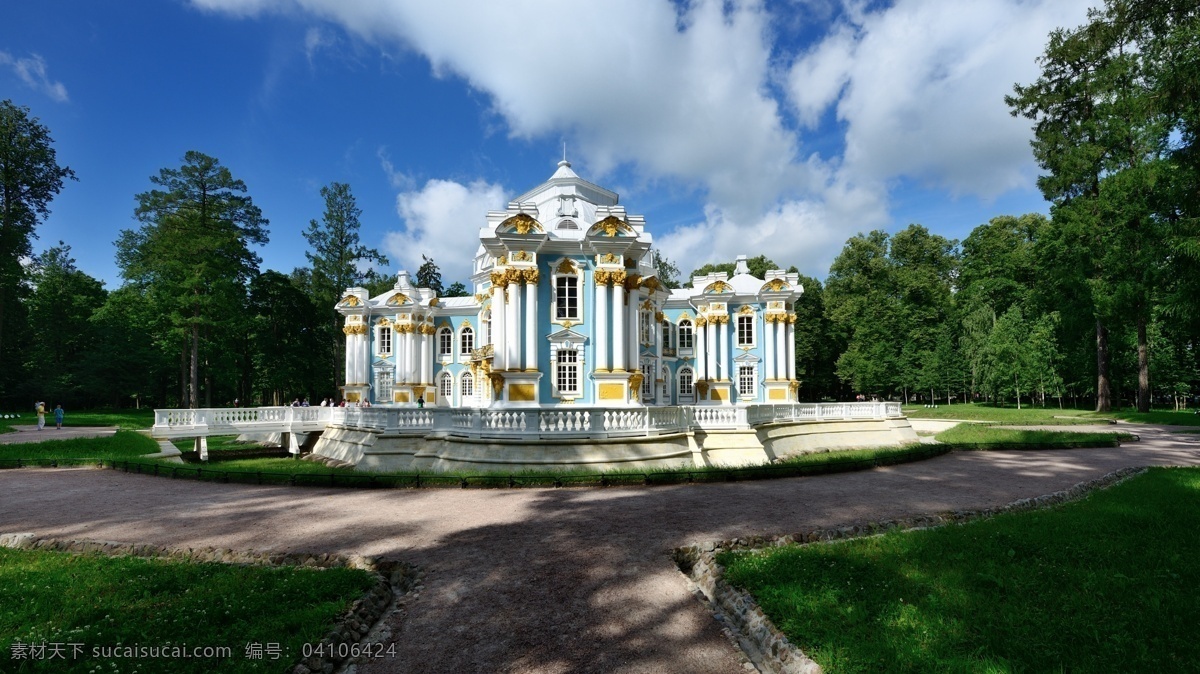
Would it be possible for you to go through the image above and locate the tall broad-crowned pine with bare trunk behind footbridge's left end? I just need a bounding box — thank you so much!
[116,151,268,407]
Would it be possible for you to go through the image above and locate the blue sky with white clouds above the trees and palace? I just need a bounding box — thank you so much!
[0,0,1098,288]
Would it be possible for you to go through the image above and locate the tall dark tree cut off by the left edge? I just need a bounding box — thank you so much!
[0,100,76,397]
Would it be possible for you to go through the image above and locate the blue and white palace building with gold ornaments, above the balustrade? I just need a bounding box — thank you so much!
[337,161,804,408]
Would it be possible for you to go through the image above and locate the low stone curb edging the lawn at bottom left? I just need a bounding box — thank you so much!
[0,532,420,674]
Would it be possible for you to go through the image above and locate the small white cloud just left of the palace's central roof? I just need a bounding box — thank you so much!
[384,180,508,279]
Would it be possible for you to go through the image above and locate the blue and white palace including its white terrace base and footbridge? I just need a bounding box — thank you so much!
[152,161,917,471]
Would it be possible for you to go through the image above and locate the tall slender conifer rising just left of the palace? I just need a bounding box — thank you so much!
[304,182,388,389]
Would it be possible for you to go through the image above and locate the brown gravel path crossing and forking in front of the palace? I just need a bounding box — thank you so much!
[0,425,1200,674]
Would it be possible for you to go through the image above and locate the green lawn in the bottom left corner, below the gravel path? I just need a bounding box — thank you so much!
[0,549,372,674]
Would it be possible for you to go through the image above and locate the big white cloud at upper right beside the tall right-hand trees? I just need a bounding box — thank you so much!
[788,0,1094,198]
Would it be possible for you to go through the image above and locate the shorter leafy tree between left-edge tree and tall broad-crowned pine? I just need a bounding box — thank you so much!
[24,241,107,405]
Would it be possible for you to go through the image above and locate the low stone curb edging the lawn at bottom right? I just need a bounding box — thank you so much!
[672,468,1147,674]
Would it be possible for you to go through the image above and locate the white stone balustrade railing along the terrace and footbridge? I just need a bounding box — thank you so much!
[154,402,902,439]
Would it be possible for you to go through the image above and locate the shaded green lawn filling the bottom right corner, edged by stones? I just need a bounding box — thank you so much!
[720,469,1200,674]
